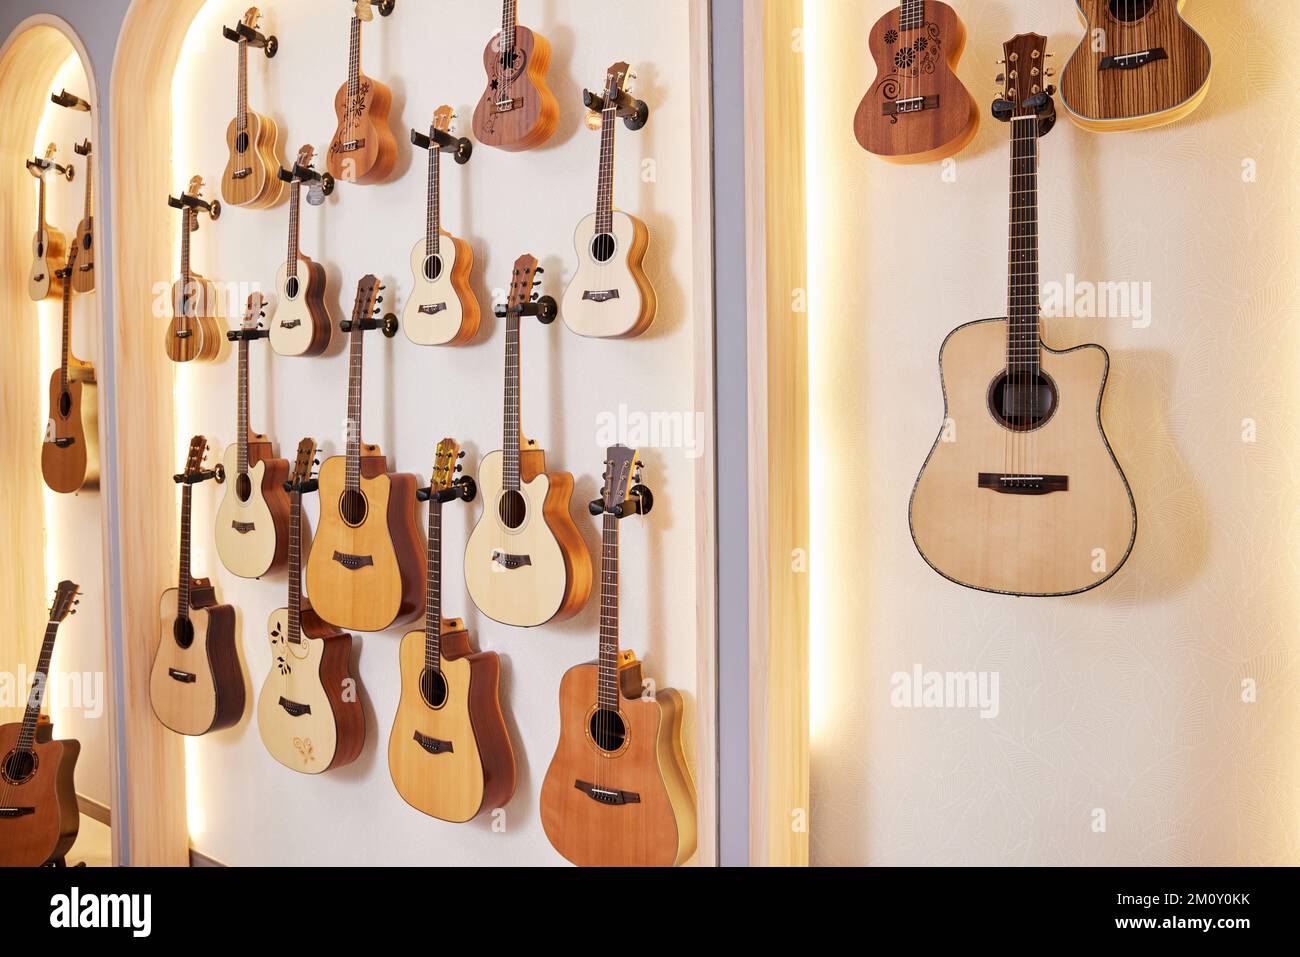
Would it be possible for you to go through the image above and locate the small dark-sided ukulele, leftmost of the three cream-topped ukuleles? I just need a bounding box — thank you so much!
[270,146,333,356]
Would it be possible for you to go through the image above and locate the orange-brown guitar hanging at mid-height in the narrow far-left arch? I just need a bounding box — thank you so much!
[40,246,99,494]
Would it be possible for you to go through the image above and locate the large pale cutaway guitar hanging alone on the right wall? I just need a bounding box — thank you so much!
[910,34,1138,596]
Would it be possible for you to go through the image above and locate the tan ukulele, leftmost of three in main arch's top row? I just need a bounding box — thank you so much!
[221,7,285,209]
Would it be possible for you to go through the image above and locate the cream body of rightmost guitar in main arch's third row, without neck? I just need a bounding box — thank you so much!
[465,450,592,628]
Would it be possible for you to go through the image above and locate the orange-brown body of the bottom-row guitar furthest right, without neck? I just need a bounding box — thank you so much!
[541,663,696,867]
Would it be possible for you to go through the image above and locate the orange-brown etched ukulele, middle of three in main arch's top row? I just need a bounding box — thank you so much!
[325,0,398,186]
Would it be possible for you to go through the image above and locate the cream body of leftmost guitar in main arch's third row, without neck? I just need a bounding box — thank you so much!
[213,434,289,579]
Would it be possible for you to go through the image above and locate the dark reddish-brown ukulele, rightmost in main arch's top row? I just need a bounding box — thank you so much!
[473,0,560,152]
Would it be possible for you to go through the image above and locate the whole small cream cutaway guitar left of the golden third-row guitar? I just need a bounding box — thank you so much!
[213,293,289,579]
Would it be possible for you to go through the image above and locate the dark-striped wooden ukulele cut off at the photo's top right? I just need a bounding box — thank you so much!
[1060,0,1210,133]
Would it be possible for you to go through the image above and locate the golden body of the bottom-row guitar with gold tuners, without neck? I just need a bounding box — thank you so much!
[389,620,515,823]
